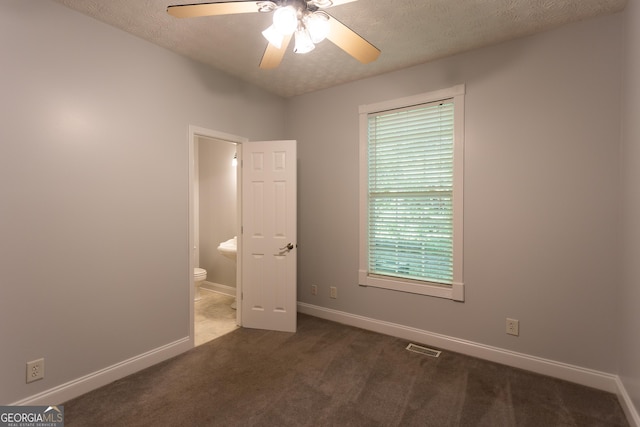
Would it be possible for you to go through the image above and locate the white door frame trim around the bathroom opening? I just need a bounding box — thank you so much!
[188,125,249,347]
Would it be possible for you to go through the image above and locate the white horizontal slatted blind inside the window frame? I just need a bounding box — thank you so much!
[367,100,454,285]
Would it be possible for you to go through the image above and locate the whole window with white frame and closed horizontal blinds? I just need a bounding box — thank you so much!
[359,85,464,301]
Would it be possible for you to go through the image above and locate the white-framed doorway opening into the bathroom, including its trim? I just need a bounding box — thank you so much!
[189,126,247,345]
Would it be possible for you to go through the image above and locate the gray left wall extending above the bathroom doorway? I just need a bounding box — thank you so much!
[0,0,284,404]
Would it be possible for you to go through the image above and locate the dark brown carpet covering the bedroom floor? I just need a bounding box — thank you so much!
[64,315,628,427]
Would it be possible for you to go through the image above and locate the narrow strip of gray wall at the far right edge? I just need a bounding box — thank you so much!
[617,1,640,409]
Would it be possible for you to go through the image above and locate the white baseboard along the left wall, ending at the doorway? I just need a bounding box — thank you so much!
[11,337,193,406]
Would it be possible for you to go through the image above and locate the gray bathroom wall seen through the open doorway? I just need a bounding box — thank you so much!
[198,137,238,287]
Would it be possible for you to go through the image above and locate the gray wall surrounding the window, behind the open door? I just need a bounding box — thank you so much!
[287,15,623,372]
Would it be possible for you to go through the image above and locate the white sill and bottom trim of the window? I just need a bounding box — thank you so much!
[358,270,464,302]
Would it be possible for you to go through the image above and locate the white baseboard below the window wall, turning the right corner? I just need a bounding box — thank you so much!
[298,302,640,427]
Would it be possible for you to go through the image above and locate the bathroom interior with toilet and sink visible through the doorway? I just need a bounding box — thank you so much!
[193,136,238,345]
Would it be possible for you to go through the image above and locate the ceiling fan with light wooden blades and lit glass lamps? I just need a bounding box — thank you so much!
[167,0,380,69]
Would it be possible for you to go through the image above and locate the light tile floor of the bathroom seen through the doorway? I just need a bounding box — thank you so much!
[194,288,238,346]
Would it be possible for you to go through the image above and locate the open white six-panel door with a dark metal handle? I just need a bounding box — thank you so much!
[240,141,297,332]
